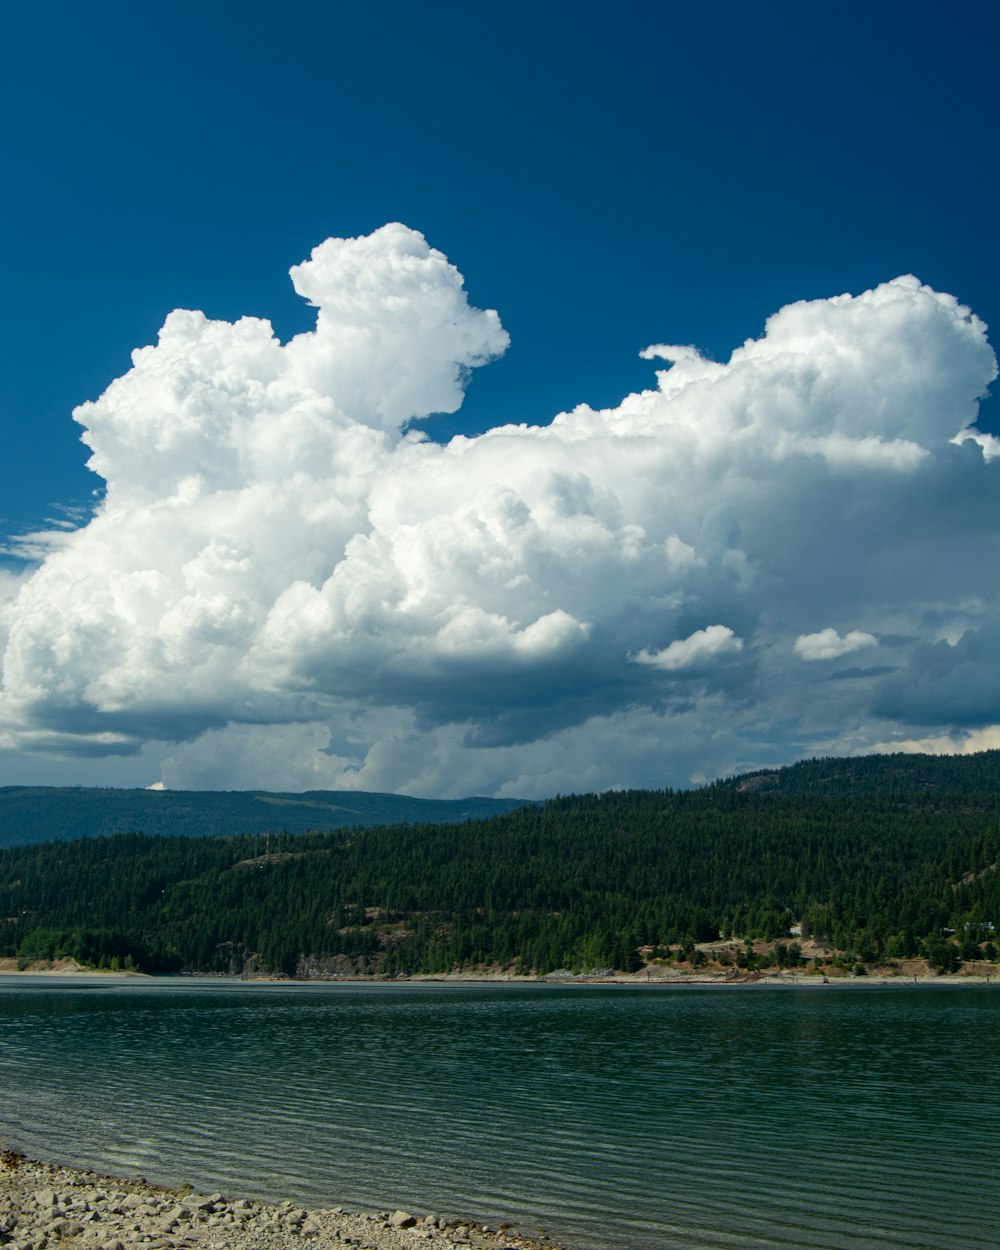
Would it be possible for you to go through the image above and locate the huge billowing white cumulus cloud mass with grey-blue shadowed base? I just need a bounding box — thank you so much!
[0,225,1000,795]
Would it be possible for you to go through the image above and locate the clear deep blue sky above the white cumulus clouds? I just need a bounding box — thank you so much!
[0,0,1000,530]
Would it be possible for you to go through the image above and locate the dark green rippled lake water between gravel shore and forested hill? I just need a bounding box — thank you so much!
[0,978,1000,1250]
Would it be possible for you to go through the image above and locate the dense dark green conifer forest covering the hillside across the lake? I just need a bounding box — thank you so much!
[0,751,1000,976]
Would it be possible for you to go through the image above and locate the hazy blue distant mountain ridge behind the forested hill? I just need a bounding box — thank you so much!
[0,786,525,849]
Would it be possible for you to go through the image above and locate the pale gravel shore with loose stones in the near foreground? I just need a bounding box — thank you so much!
[0,1151,560,1250]
